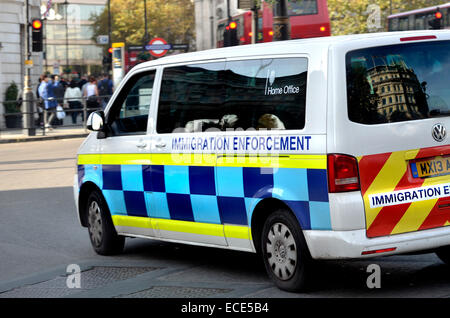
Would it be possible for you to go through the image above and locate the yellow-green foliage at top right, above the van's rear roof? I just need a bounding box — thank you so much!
[328,0,445,35]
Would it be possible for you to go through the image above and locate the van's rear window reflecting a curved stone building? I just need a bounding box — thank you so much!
[346,41,450,125]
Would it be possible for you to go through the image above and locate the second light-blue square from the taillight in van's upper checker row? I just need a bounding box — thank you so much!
[216,167,244,198]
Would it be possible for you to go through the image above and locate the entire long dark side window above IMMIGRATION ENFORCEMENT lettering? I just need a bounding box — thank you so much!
[157,58,307,133]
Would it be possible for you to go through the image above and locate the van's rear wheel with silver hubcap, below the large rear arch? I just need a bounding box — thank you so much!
[261,210,311,291]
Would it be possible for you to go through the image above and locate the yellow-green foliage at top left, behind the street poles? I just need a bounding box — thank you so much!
[91,0,195,45]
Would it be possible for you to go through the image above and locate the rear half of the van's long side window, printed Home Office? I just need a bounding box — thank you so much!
[222,58,307,130]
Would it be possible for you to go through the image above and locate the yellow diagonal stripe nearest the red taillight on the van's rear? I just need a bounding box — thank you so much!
[364,150,418,228]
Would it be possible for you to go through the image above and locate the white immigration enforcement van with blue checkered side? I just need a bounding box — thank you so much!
[74,31,450,291]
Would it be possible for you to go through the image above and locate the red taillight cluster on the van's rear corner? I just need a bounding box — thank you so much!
[327,154,360,193]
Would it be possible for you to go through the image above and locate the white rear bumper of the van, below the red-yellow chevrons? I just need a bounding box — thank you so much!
[303,226,450,259]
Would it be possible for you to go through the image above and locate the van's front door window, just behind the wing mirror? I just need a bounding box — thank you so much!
[108,71,155,136]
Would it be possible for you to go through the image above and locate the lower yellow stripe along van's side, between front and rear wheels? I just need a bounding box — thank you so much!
[112,215,251,240]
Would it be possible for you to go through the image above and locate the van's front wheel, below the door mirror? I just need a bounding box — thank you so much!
[86,191,125,255]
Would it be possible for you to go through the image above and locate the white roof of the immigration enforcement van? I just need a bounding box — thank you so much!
[135,30,450,69]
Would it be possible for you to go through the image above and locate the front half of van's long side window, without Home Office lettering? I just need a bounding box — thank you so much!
[156,62,225,133]
